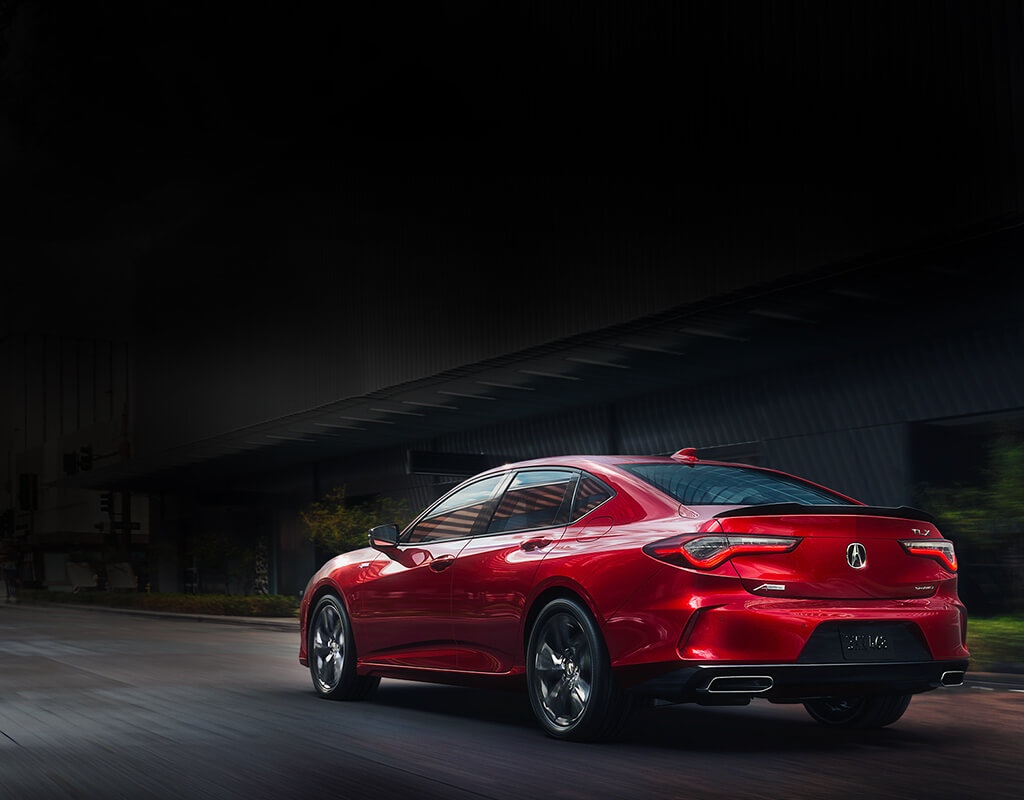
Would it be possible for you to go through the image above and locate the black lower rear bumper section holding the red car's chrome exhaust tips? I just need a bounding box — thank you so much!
[631,660,968,706]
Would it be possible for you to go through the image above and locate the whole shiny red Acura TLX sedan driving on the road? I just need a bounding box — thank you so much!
[299,449,969,740]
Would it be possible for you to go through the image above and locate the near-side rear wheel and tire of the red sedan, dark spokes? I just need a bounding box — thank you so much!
[526,597,632,742]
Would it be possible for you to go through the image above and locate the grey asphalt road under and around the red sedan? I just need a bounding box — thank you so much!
[0,606,1024,800]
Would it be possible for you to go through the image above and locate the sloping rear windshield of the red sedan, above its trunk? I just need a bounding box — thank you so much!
[617,463,850,506]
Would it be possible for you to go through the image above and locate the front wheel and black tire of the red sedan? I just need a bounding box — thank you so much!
[306,594,381,700]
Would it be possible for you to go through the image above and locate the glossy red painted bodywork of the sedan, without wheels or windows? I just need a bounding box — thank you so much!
[299,454,969,700]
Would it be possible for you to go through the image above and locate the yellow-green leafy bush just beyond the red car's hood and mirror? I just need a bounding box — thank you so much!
[300,487,411,553]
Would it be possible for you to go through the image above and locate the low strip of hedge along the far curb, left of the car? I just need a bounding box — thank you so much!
[18,589,299,617]
